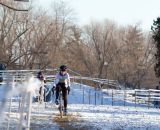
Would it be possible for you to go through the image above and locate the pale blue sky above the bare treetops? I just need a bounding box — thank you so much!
[36,0,160,30]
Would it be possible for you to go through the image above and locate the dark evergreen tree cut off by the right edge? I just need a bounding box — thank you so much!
[151,17,160,77]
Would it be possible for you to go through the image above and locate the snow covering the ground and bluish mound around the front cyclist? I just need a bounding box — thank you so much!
[0,83,160,130]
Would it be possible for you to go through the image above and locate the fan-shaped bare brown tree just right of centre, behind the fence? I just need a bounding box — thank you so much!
[85,22,116,78]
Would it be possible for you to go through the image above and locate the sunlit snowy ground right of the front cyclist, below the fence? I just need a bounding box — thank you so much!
[70,105,160,130]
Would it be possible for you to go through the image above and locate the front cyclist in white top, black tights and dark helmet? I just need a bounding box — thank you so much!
[52,65,70,113]
